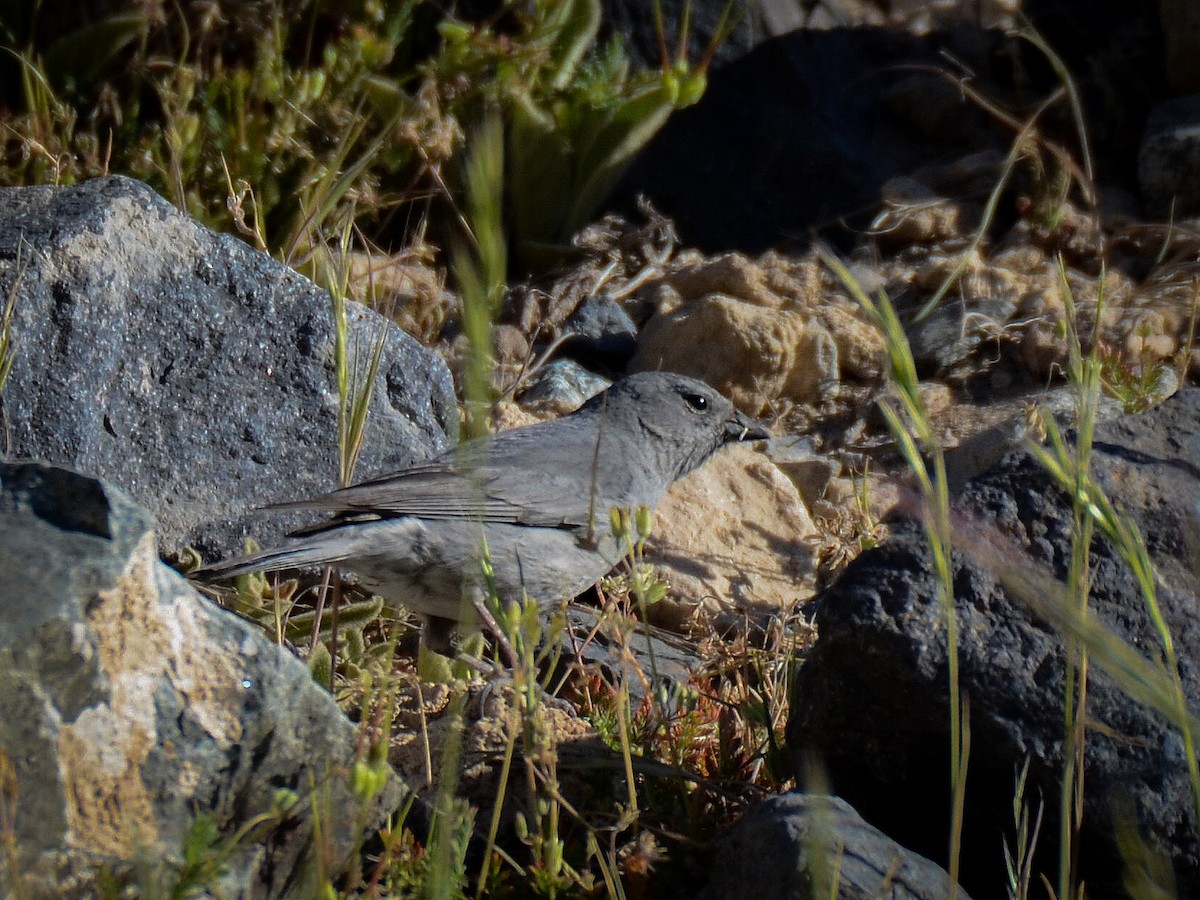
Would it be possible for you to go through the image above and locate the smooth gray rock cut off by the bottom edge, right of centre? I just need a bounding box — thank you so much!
[701,791,971,900]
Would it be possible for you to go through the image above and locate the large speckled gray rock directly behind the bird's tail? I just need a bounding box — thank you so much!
[0,178,457,557]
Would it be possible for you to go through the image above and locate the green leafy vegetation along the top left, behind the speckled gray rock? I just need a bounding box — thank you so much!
[0,0,732,282]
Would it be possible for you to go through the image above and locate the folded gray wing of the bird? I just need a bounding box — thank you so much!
[274,424,628,528]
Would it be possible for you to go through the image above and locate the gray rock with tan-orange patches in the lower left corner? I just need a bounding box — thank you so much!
[0,463,404,898]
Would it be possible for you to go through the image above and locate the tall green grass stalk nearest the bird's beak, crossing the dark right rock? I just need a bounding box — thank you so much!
[821,250,971,896]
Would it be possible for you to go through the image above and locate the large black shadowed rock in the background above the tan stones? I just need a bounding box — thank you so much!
[617,29,995,253]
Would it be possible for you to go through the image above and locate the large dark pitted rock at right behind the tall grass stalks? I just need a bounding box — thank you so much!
[788,389,1200,898]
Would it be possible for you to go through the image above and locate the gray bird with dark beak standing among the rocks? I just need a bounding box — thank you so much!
[196,372,767,652]
